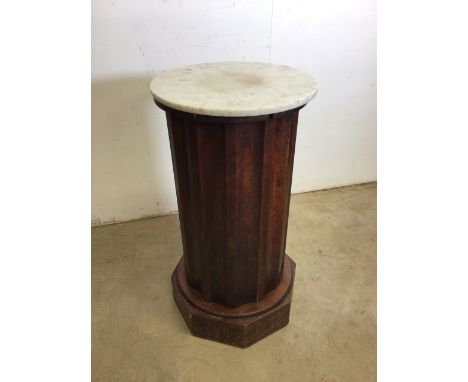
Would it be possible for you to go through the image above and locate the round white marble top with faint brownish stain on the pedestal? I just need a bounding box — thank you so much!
[151,62,317,117]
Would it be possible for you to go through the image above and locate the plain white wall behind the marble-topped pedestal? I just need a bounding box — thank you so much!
[92,0,376,225]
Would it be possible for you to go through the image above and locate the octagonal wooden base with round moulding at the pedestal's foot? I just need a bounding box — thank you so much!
[171,255,296,348]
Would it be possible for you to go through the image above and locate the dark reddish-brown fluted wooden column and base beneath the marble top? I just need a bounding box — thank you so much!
[158,104,300,346]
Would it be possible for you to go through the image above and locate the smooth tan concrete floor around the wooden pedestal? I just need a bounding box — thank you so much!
[92,183,376,382]
